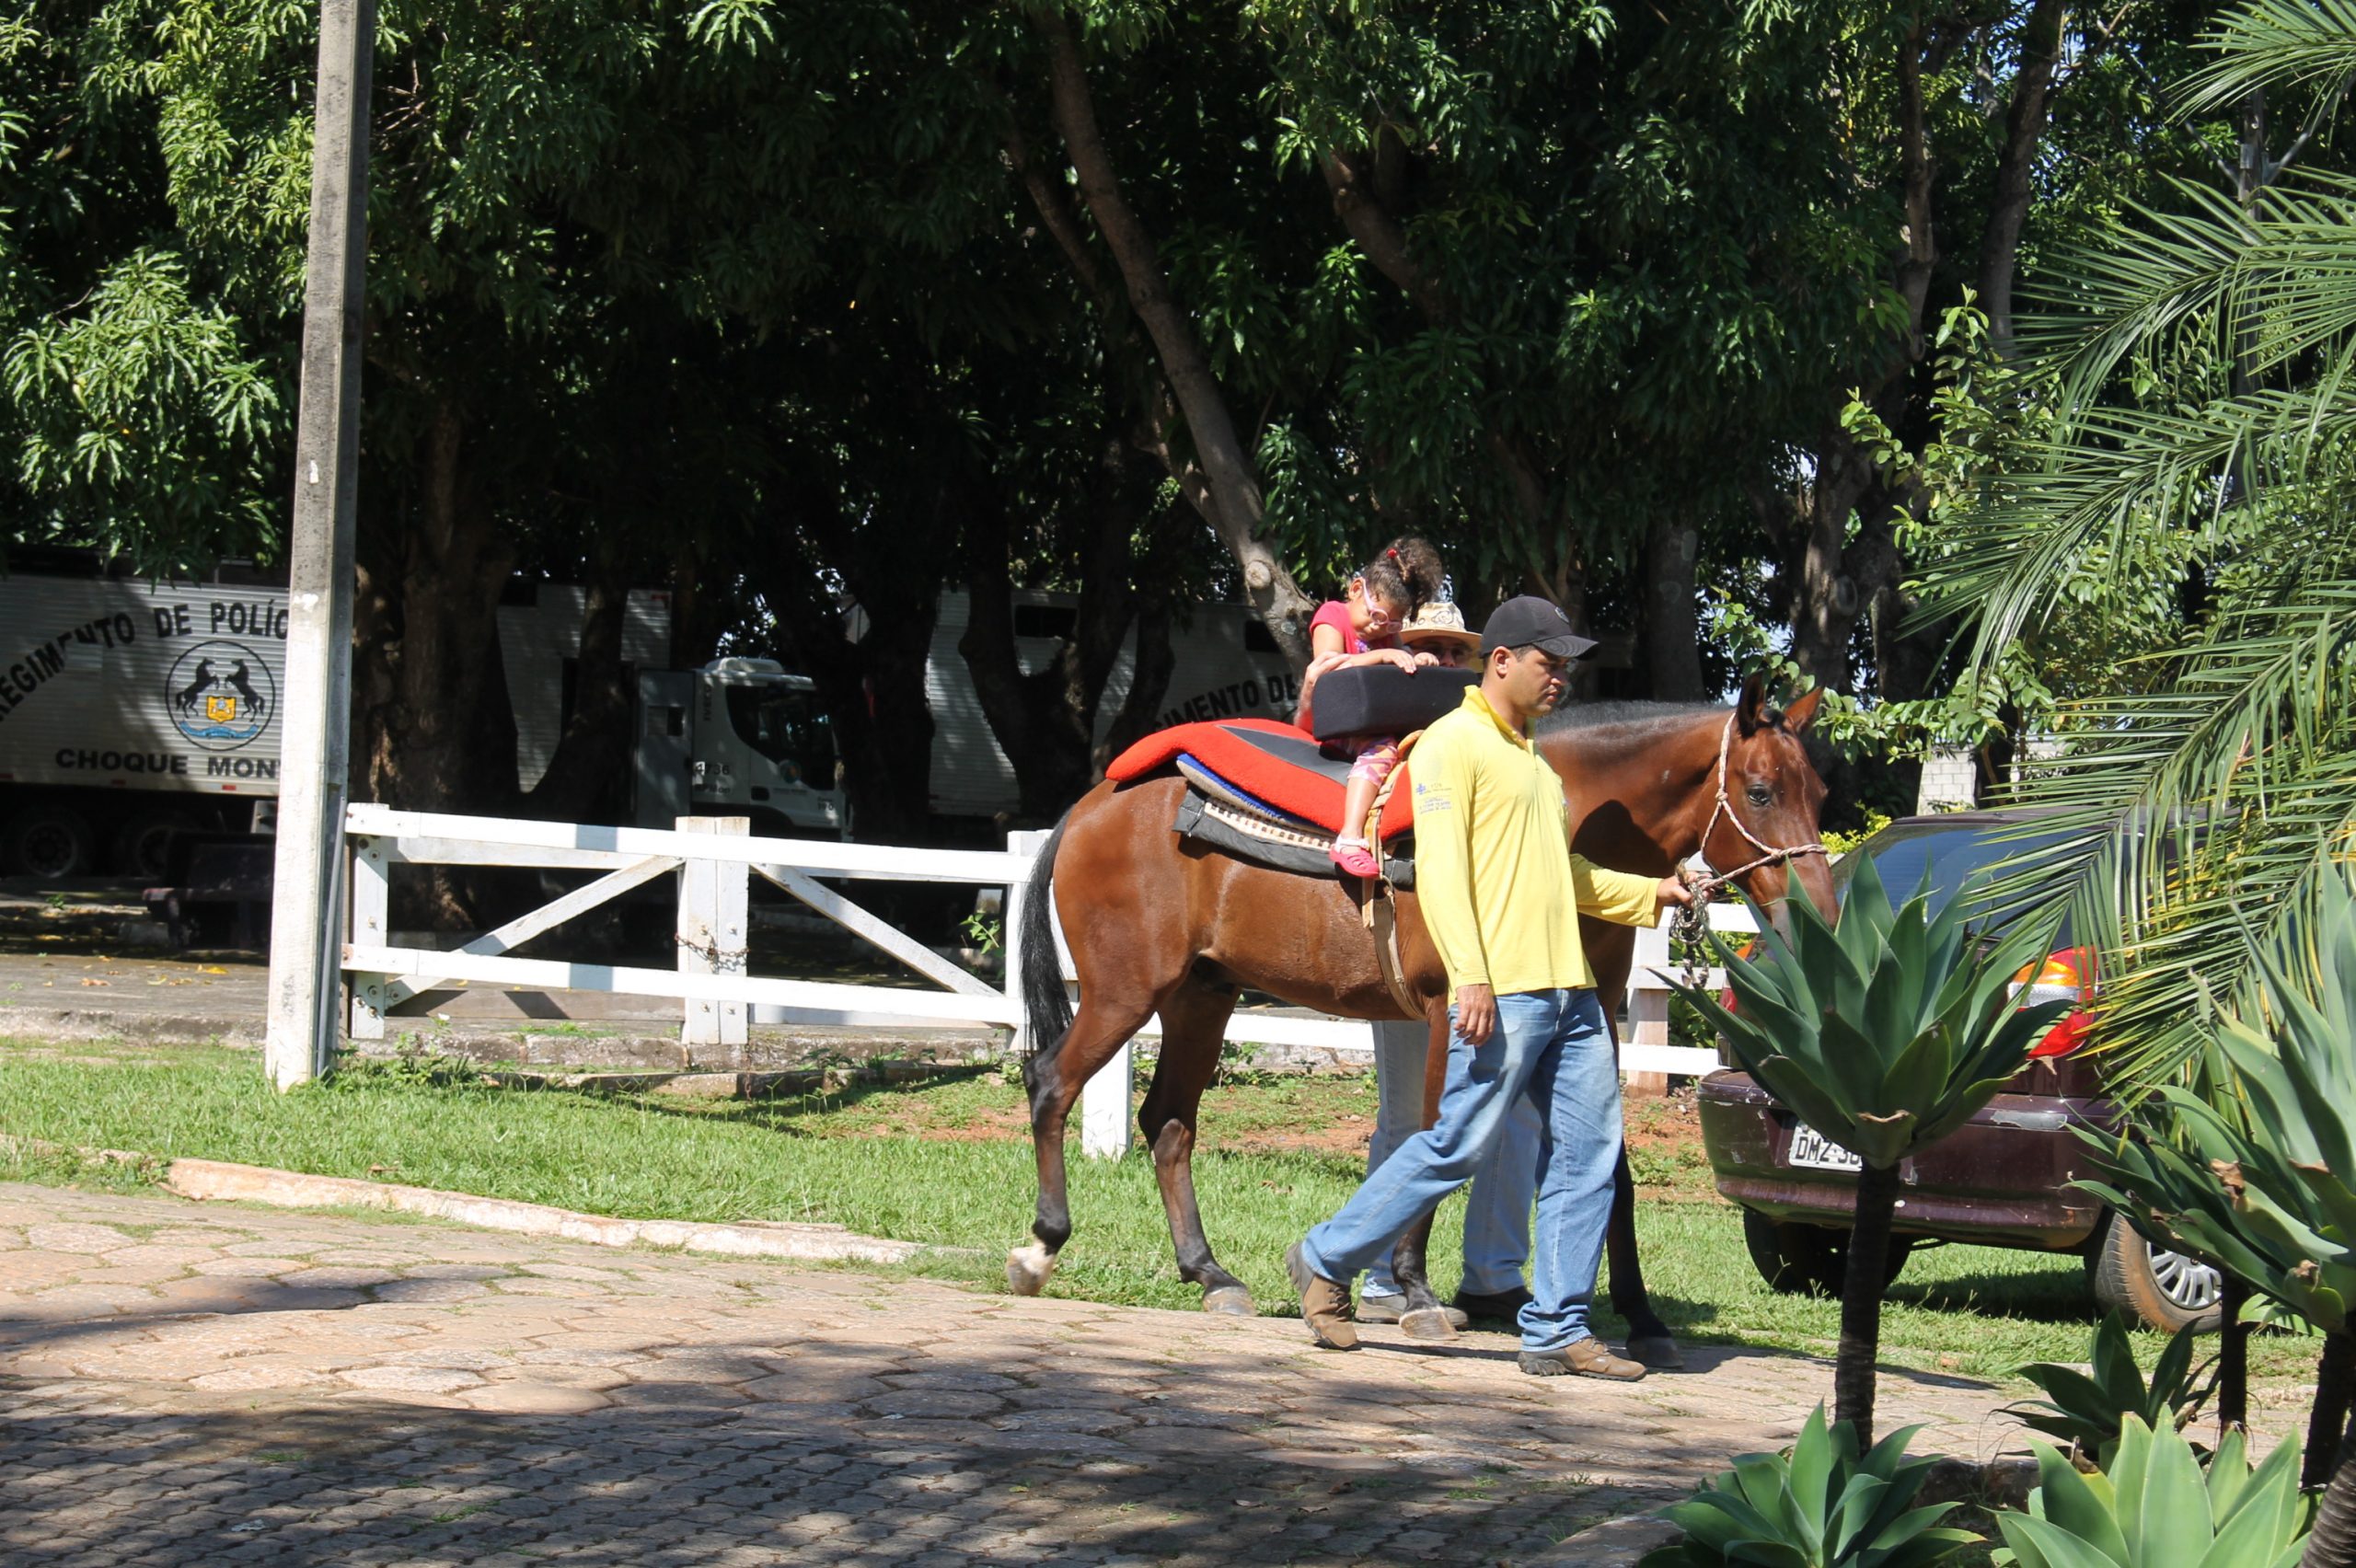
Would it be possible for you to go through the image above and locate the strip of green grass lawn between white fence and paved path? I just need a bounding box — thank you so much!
[0,1038,2314,1387]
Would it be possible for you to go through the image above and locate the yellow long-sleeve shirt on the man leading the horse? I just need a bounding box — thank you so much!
[1414,687,1658,996]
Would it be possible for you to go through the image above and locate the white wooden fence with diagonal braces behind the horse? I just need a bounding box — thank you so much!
[344,805,1750,1154]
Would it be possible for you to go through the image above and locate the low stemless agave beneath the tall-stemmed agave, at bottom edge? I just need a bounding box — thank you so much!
[1640,1405,1981,1568]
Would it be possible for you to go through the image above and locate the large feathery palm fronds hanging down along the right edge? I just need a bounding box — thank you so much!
[1923,0,2356,1092]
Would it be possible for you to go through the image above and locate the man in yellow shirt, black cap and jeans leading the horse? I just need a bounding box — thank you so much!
[1284,595,1692,1379]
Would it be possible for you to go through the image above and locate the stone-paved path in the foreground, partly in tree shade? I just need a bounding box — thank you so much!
[0,1184,2010,1568]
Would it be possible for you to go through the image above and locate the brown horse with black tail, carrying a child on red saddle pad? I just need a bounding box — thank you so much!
[1006,680,1831,1366]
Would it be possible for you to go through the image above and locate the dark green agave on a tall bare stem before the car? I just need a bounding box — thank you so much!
[1678,859,2066,1443]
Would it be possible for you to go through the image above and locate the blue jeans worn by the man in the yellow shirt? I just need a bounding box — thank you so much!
[1300,991,1621,1352]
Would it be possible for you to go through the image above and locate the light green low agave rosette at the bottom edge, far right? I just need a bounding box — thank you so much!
[1995,1415,2311,1568]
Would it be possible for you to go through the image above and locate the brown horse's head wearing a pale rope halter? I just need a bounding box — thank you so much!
[1701,675,1833,930]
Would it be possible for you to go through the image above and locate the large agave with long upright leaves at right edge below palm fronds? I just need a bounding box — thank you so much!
[2080,876,2356,1332]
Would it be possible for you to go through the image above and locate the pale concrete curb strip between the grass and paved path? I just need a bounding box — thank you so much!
[163,1160,947,1262]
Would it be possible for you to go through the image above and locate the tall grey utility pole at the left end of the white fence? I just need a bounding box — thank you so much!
[261,0,377,1088]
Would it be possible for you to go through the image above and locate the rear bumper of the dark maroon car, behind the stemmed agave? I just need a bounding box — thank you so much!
[1699,1071,2113,1252]
